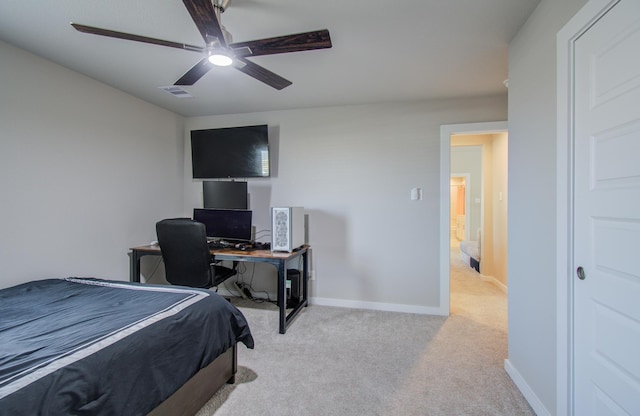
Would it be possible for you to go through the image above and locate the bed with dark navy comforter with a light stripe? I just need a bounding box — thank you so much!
[0,278,253,416]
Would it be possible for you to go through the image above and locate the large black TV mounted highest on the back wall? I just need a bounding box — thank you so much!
[191,124,269,179]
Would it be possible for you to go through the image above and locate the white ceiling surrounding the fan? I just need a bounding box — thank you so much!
[0,0,539,116]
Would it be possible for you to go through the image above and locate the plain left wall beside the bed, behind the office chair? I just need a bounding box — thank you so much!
[0,42,184,287]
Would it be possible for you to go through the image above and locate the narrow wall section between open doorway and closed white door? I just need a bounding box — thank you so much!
[506,0,586,414]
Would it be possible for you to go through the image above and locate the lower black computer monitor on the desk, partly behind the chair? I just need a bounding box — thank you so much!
[193,208,252,241]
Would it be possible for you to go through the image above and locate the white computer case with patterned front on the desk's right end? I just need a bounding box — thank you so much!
[271,207,305,252]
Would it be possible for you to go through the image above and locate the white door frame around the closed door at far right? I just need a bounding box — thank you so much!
[556,0,621,415]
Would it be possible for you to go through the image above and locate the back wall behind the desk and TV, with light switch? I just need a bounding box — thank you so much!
[184,97,506,313]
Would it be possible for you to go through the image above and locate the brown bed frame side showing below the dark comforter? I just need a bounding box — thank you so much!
[147,344,238,416]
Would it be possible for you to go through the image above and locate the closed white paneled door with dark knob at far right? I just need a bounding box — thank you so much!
[573,0,640,416]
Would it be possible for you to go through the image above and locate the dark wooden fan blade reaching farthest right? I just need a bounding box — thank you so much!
[229,29,331,56]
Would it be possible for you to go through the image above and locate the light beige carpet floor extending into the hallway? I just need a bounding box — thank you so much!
[198,242,534,416]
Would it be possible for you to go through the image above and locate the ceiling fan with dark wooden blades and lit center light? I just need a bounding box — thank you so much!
[71,0,331,90]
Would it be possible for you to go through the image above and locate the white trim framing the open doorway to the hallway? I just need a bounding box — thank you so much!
[438,121,508,316]
